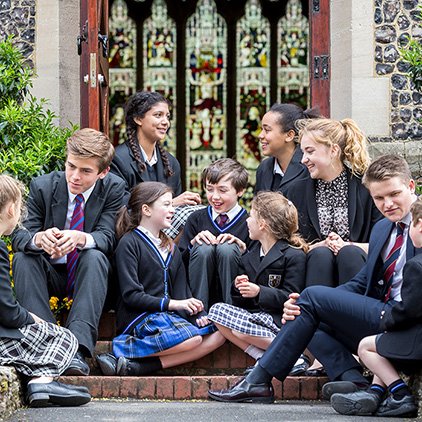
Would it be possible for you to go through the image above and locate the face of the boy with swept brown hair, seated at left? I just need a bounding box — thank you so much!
[65,153,109,195]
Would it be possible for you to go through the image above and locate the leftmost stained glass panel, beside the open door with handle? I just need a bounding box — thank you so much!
[109,0,136,144]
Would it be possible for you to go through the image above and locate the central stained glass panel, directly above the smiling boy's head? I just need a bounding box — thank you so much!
[186,0,227,195]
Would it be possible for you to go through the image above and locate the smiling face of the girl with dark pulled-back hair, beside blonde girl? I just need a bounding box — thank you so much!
[258,111,295,158]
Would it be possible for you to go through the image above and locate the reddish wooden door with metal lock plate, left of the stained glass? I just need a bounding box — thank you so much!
[78,0,109,134]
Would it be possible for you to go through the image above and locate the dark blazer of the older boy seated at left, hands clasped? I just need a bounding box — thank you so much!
[12,171,125,255]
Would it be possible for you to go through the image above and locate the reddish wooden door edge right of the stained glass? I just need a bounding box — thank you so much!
[309,0,330,117]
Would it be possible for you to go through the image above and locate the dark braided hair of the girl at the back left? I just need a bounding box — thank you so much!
[125,91,174,177]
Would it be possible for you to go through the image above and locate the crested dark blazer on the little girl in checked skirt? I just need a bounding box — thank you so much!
[231,240,306,327]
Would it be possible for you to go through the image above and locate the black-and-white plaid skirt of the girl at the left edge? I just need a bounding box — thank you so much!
[0,322,78,377]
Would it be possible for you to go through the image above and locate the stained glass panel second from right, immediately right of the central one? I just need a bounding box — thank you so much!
[236,0,270,200]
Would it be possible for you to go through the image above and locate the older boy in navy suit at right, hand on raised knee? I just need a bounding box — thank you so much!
[209,155,421,402]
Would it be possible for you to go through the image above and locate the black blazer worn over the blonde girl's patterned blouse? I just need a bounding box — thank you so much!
[286,169,382,243]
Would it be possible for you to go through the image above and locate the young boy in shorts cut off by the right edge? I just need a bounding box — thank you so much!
[331,198,422,417]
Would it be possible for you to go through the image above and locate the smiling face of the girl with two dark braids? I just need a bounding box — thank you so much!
[134,103,170,143]
